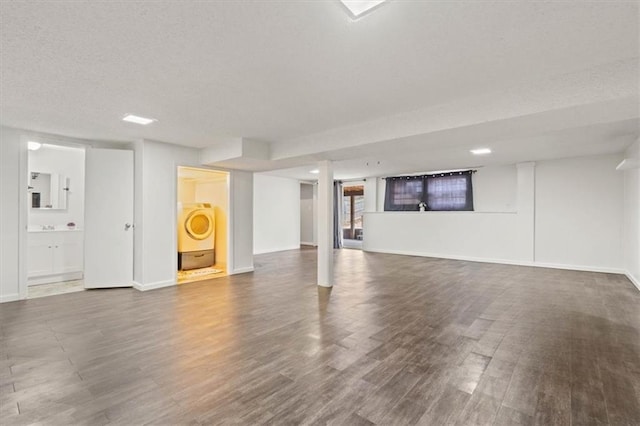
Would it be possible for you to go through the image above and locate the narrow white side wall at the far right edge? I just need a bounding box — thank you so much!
[623,139,640,290]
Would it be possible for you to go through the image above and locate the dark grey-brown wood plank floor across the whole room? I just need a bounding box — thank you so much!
[0,250,640,425]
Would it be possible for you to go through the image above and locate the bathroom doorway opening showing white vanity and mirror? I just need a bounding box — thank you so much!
[26,141,85,299]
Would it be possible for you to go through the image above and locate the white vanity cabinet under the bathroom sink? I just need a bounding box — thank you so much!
[27,230,84,285]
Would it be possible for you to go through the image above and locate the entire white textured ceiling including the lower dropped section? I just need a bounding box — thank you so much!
[0,0,640,178]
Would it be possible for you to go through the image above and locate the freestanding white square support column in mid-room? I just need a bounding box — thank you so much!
[318,161,333,287]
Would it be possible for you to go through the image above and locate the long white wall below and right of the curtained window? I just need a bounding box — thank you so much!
[364,155,624,272]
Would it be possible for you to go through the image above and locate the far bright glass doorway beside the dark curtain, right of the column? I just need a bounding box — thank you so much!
[342,182,364,249]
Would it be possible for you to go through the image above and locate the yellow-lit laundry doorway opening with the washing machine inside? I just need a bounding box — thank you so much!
[176,166,229,284]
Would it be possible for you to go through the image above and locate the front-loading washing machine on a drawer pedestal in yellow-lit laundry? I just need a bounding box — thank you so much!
[178,203,216,271]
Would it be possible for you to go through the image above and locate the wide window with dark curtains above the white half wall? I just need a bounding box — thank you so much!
[384,170,473,211]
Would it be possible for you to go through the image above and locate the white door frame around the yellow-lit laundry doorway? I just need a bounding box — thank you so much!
[171,163,235,285]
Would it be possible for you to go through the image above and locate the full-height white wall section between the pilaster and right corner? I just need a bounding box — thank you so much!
[535,155,624,270]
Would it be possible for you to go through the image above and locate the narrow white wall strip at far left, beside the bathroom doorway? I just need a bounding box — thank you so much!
[0,127,26,302]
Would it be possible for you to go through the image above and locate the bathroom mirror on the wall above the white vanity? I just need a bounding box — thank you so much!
[29,172,69,210]
